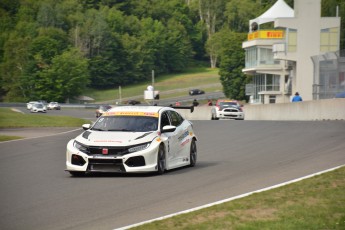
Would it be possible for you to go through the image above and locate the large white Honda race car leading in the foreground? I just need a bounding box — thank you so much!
[66,106,197,176]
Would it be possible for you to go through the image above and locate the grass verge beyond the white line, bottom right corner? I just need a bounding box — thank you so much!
[133,167,345,230]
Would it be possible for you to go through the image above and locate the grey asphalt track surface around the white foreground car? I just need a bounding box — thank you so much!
[0,116,345,230]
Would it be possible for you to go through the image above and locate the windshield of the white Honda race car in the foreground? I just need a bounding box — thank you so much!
[91,116,158,132]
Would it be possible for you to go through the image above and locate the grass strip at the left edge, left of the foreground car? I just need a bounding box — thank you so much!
[0,108,90,128]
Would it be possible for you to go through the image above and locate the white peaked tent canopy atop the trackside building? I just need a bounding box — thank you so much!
[249,0,295,28]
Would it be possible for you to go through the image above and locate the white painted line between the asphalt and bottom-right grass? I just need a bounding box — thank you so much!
[114,165,345,230]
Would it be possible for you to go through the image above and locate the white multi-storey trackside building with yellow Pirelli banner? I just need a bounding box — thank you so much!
[242,0,340,104]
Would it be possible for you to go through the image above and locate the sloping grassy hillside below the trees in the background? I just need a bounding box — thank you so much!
[84,67,222,102]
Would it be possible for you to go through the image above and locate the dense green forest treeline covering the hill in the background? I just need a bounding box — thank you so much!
[0,0,345,102]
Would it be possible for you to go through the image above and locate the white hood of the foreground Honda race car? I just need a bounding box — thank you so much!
[75,130,157,146]
